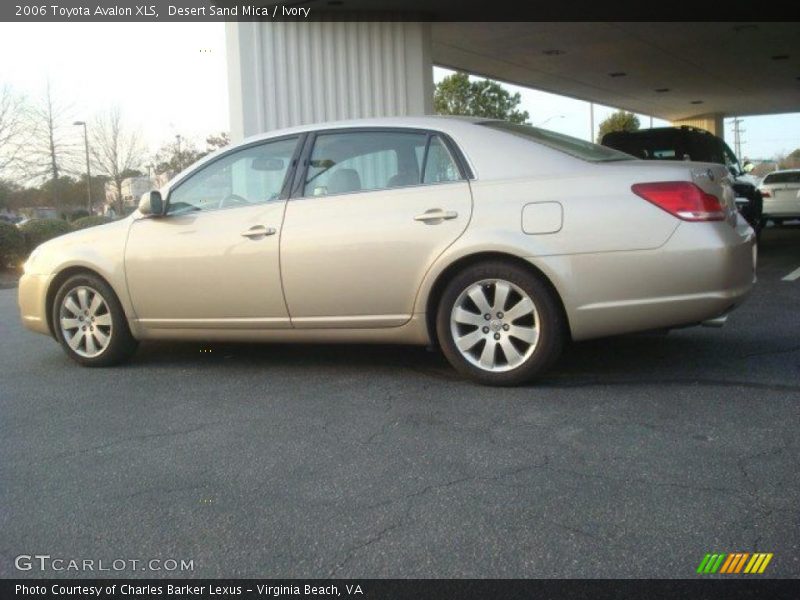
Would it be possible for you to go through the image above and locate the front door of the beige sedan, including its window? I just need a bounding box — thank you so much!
[125,137,298,329]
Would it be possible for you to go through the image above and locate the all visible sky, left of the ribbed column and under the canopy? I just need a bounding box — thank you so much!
[0,23,800,165]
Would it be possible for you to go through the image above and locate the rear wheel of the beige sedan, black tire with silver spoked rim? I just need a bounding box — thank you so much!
[436,261,568,386]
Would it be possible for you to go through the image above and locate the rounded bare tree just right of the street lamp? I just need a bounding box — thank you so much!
[90,106,143,214]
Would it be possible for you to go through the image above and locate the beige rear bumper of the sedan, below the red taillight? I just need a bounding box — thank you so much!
[545,220,756,340]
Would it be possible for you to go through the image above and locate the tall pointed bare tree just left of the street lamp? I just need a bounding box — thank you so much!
[26,80,75,207]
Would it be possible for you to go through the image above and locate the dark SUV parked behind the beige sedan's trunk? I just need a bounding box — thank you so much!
[601,126,762,232]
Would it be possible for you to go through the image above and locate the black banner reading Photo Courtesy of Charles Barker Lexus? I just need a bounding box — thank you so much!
[0,577,800,600]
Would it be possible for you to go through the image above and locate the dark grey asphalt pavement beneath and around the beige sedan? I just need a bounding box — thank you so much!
[0,226,800,578]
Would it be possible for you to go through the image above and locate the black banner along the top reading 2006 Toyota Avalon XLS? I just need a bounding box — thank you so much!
[0,0,797,22]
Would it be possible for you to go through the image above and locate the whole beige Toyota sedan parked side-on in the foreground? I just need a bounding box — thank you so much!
[19,117,755,385]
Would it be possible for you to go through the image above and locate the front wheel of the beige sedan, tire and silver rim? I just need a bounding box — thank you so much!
[52,273,138,367]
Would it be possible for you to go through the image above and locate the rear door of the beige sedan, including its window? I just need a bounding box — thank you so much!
[281,129,472,328]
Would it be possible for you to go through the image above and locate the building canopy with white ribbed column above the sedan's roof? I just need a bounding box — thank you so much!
[222,19,800,141]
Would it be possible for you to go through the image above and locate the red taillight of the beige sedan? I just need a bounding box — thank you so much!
[631,181,725,221]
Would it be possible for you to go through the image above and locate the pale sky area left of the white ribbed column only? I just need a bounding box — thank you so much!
[0,23,229,161]
